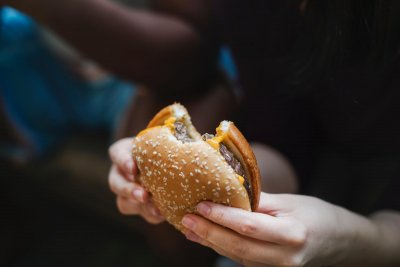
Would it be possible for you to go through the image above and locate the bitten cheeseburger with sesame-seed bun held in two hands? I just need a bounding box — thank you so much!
[132,104,260,230]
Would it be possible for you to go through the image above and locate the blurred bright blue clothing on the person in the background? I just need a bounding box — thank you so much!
[0,7,135,159]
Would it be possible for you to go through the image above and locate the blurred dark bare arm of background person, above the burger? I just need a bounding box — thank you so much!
[10,0,216,91]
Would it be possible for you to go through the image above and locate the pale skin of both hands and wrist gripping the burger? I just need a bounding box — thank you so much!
[109,138,400,267]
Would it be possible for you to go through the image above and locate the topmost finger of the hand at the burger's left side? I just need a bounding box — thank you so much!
[109,138,137,175]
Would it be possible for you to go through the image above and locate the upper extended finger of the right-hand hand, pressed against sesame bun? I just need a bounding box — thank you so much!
[197,202,305,245]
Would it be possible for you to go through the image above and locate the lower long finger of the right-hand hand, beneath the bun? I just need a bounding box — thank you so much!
[182,214,290,266]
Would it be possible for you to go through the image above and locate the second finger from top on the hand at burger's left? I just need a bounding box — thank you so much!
[108,165,149,203]
